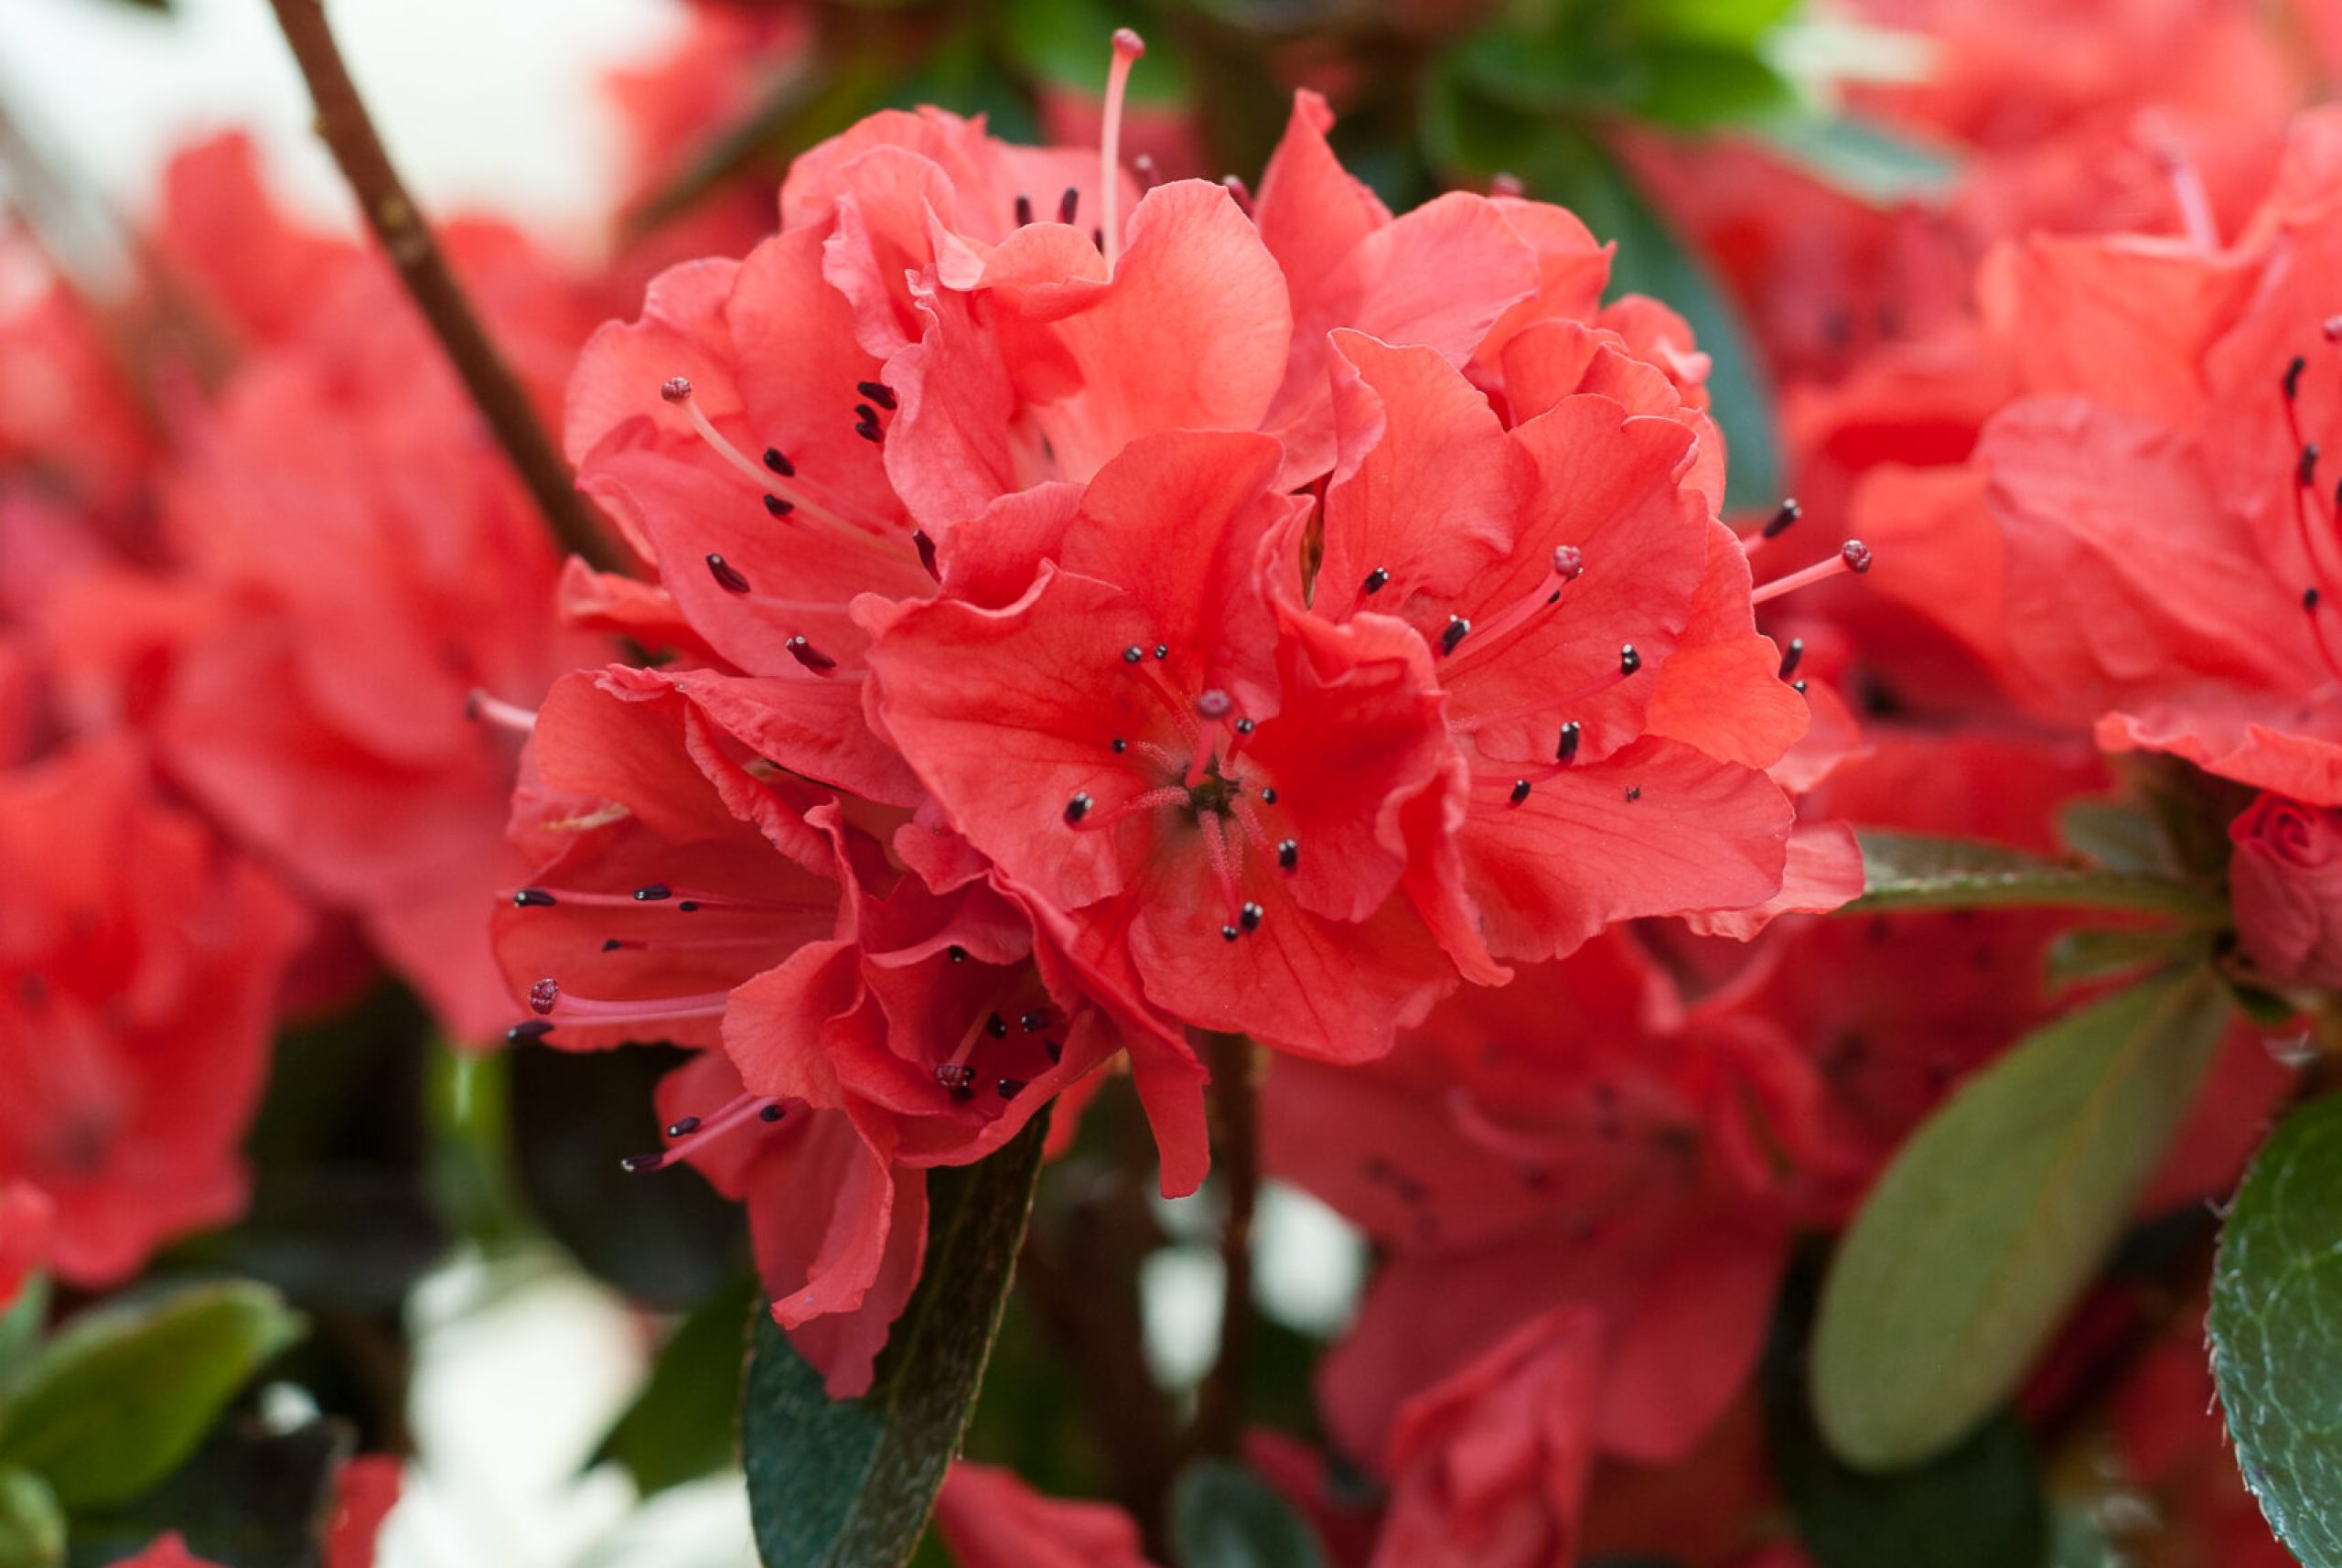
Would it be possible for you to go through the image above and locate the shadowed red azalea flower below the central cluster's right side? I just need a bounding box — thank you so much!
[1262,931,1808,1463]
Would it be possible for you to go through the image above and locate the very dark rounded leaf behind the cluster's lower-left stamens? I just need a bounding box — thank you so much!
[506,1047,747,1311]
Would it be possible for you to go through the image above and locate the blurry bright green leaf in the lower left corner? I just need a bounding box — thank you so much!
[0,1280,302,1512]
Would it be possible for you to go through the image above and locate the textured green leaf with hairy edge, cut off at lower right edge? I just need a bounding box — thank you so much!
[2211,1098,2342,1568]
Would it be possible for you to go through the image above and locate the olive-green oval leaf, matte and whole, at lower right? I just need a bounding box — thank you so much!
[1812,969,2229,1470]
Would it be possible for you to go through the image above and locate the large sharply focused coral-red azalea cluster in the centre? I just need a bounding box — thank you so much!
[497,64,1862,1395]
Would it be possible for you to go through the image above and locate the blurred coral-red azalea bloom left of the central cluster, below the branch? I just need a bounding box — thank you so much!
[97,227,595,1039]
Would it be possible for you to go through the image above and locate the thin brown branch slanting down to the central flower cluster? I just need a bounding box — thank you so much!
[269,0,618,571]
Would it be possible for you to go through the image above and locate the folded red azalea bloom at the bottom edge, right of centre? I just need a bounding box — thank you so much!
[1375,1305,1602,1568]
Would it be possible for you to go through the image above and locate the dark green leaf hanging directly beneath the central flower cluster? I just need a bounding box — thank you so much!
[740,1112,1049,1568]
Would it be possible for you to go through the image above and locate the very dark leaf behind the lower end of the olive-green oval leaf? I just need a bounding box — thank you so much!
[1764,1269,2045,1568]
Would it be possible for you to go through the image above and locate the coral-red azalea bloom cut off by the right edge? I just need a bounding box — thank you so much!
[1979,114,2342,805]
